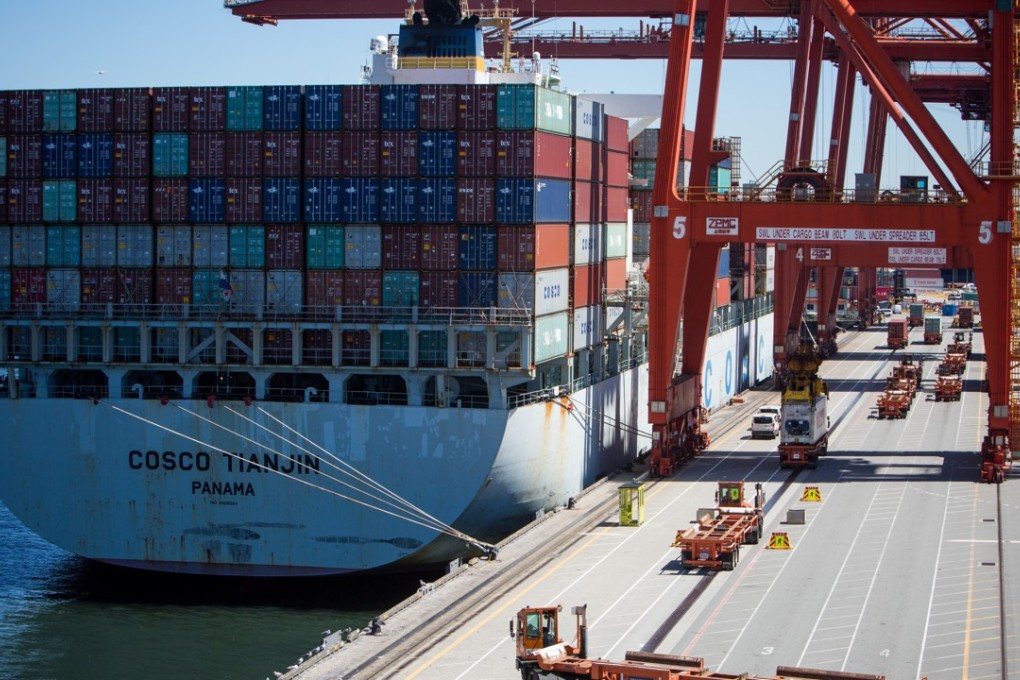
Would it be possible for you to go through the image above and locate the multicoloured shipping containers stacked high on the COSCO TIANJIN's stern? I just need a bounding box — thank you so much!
[0,85,628,375]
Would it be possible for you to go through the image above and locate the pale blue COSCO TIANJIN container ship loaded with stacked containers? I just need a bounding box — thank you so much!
[0,7,771,576]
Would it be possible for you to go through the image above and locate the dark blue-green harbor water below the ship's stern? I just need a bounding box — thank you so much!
[0,504,438,680]
